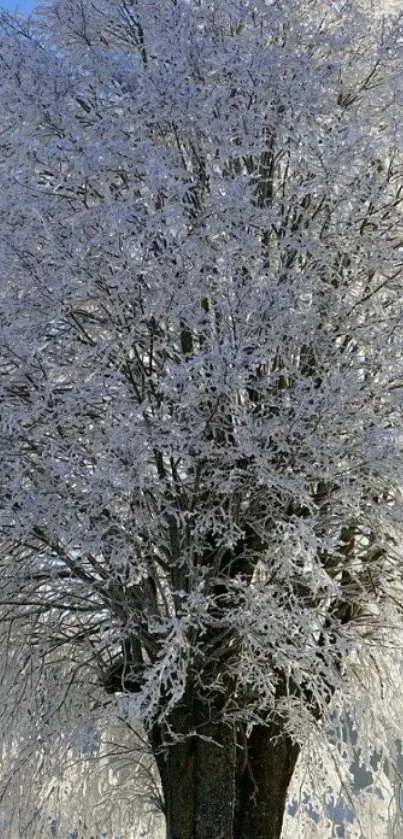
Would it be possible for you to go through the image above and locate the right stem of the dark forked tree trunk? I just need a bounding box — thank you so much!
[232,719,300,839]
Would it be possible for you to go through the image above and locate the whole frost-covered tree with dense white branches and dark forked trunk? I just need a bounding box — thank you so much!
[0,0,403,839]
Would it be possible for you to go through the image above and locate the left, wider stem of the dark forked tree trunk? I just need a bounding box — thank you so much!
[153,708,236,839]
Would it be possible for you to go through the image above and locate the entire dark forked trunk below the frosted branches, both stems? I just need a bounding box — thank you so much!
[153,706,299,839]
